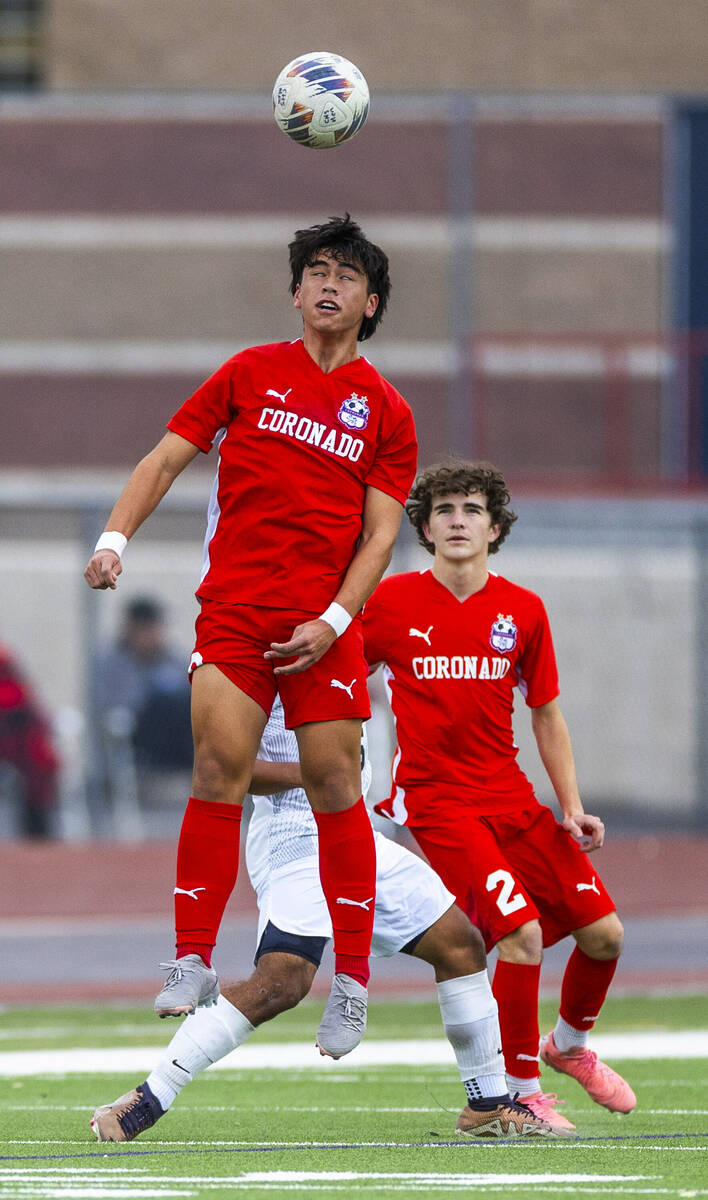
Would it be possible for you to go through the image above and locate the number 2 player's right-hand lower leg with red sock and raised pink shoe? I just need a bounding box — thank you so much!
[541,912,637,1112]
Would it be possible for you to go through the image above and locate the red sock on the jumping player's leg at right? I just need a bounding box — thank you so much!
[314,798,376,988]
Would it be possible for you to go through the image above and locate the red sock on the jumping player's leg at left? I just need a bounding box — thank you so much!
[174,796,241,967]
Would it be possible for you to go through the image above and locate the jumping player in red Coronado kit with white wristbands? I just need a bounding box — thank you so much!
[85,215,416,1057]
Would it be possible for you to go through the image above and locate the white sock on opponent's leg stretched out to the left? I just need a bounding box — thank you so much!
[148,996,254,1109]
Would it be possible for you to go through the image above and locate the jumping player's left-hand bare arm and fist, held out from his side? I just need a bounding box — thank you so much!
[84,432,199,590]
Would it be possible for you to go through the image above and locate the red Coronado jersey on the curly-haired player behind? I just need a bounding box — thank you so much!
[364,570,558,824]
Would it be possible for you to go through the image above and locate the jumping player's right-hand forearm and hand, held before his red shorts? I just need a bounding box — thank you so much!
[265,487,403,674]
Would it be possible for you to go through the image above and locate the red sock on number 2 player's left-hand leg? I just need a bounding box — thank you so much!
[492,960,541,1079]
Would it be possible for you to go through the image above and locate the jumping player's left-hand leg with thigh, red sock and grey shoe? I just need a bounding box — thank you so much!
[155,664,266,1016]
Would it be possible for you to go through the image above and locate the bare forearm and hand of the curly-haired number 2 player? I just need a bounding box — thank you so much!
[532,700,605,851]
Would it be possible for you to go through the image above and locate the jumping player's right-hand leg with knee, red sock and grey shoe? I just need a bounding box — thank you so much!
[295,720,376,1058]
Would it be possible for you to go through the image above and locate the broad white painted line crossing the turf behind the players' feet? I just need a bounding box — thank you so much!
[0,1030,708,1076]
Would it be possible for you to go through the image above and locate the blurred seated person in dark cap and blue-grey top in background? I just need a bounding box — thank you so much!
[90,596,193,832]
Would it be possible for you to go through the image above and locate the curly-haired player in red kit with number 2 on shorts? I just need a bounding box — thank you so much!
[364,461,636,1129]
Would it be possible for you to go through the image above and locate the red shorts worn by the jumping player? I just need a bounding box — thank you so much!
[190,600,371,730]
